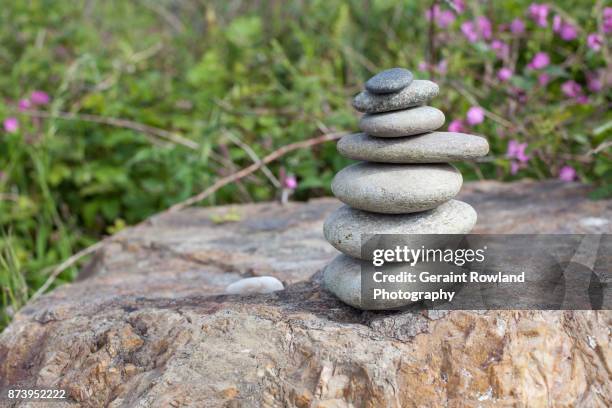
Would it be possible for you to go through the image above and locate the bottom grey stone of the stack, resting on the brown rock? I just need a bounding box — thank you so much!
[322,255,464,310]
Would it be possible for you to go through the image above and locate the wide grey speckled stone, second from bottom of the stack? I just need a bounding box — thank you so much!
[323,200,476,259]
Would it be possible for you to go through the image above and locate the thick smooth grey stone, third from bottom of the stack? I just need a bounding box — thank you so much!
[331,162,463,214]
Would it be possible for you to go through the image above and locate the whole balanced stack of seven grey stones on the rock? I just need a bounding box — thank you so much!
[323,68,489,309]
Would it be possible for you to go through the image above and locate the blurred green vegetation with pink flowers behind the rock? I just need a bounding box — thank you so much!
[0,0,612,327]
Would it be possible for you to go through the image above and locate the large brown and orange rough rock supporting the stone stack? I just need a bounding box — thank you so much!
[0,181,612,408]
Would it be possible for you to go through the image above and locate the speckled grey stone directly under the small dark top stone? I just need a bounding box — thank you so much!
[353,79,440,113]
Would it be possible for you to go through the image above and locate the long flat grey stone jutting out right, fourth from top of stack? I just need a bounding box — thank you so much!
[337,132,489,163]
